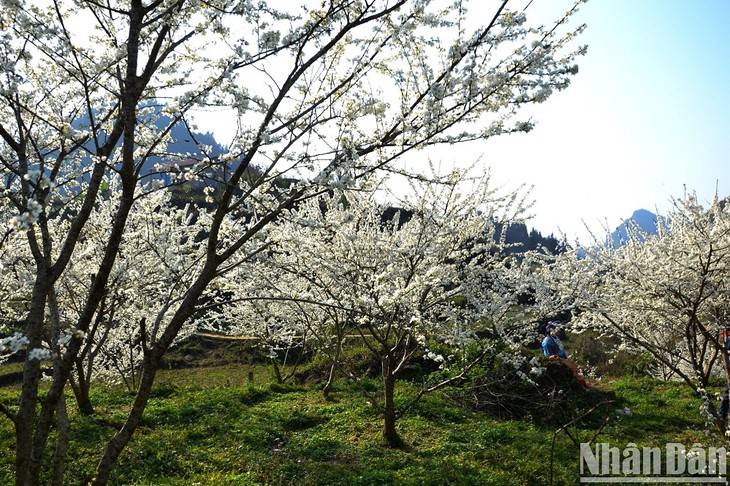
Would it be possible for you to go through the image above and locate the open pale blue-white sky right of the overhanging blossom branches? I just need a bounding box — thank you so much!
[472,0,730,241]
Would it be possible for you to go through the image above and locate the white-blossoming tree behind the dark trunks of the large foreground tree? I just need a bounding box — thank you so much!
[56,185,205,406]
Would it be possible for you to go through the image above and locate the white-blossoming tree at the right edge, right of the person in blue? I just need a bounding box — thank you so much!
[548,195,730,430]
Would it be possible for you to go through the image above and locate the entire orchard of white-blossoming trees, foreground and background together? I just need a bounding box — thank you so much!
[0,0,730,485]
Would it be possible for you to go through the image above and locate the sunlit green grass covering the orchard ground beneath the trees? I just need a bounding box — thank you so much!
[0,365,720,486]
